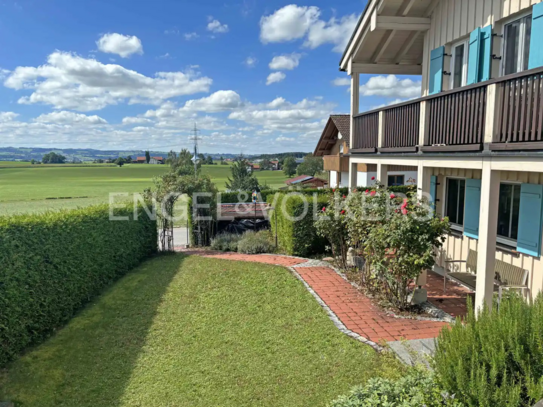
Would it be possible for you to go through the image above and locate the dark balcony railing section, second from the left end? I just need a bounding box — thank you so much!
[379,102,420,153]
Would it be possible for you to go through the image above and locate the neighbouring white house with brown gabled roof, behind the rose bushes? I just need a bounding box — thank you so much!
[313,114,418,188]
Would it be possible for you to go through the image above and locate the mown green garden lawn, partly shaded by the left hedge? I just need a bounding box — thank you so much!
[0,255,399,407]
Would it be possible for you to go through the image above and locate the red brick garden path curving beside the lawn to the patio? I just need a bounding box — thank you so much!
[180,251,466,343]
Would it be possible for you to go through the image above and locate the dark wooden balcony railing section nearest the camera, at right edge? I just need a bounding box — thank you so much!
[491,72,543,150]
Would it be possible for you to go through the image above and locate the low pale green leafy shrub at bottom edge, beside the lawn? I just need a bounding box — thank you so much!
[330,368,461,407]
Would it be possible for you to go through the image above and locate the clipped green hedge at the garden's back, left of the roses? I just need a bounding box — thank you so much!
[268,191,329,257]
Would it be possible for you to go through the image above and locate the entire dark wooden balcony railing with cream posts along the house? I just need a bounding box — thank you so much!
[351,68,543,154]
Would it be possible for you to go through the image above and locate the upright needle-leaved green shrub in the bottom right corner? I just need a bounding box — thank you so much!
[434,295,543,407]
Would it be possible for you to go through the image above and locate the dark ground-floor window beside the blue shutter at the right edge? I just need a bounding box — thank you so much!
[498,184,520,243]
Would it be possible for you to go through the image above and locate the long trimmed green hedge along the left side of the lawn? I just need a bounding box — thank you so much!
[0,205,157,366]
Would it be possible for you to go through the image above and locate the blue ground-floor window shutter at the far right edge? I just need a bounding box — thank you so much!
[517,184,543,257]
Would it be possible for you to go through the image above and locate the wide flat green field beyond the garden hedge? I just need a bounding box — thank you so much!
[0,161,286,215]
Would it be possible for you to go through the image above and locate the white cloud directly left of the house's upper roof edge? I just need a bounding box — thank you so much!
[304,14,358,52]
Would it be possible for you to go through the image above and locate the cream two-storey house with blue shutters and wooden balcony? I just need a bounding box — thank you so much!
[340,0,543,308]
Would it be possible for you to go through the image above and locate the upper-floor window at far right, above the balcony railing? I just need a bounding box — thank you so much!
[503,14,532,75]
